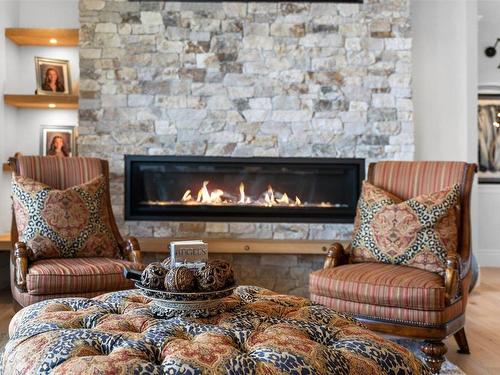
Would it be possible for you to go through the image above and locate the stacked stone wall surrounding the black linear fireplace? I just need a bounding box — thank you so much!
[78,0,414,296]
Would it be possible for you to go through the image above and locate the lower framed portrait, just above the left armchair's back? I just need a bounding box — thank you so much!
[40,125,76,157]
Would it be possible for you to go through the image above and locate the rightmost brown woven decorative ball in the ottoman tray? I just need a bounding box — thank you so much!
[196,260,234,292]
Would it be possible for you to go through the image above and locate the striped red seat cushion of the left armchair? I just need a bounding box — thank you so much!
[26,258,142,295]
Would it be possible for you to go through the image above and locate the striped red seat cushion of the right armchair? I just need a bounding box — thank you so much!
[309,263,445,311]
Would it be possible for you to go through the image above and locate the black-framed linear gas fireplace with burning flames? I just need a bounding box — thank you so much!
[125,155,364,223]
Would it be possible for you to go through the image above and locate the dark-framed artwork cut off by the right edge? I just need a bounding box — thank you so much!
[477,94,500,183]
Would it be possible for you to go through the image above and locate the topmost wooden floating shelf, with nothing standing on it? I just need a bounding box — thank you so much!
[5,28,78,47]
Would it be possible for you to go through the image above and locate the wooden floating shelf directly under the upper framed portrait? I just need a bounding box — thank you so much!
[3,94,78,109]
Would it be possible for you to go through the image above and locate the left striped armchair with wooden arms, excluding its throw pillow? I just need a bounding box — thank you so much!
[9,156,143,309]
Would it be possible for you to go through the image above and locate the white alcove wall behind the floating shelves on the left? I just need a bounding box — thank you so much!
[0,0,79,233]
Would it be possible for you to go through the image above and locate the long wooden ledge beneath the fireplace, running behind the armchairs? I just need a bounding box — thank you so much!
[0,233,340,255]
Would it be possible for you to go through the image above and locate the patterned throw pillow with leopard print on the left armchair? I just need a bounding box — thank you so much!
[12,175,118,260]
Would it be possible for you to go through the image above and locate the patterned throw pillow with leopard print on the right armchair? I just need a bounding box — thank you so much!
[351,181,460,273]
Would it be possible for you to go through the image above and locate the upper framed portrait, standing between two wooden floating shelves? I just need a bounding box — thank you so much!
[35,56,71,95]
